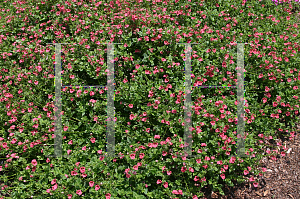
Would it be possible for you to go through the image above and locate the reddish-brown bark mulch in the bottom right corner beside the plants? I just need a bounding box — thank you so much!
[201,116,300,199]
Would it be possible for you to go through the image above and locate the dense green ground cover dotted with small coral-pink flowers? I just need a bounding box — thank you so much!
[0,0,300,199]
